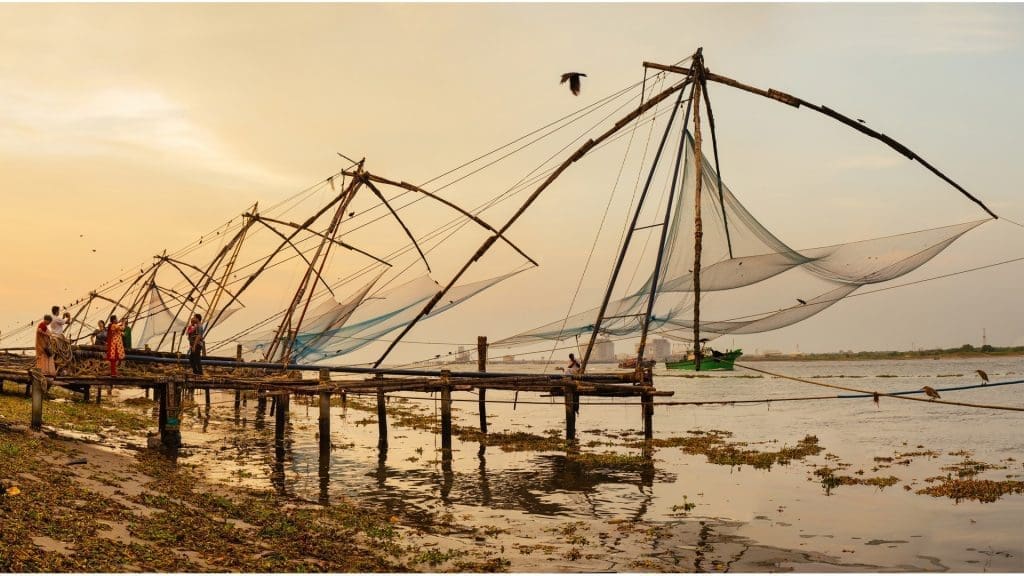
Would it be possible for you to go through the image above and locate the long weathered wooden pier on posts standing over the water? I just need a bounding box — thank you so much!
[0,337,673,459]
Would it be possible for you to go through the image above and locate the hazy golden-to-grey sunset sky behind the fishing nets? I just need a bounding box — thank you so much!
[0,3,1024,360]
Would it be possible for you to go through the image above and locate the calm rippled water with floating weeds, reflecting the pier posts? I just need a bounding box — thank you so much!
[136,358,1024,572]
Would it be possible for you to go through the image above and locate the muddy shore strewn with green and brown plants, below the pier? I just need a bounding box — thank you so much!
[0,386,897,572]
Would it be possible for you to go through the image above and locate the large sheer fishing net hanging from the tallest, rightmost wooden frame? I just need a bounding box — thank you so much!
[492,132,987,347]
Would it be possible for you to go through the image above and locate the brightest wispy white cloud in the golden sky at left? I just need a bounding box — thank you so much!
[0,85,287,184]
